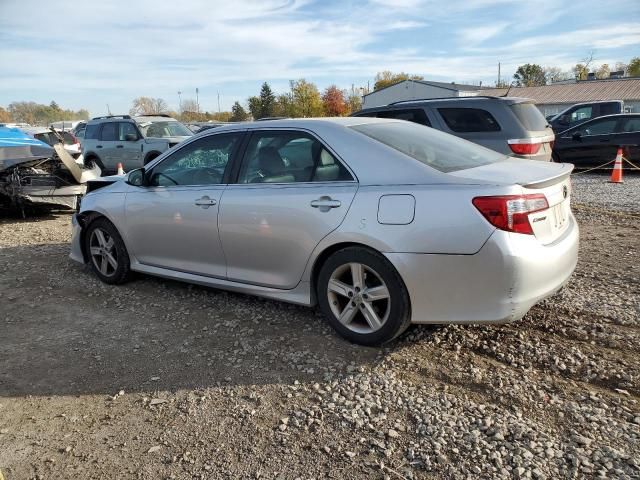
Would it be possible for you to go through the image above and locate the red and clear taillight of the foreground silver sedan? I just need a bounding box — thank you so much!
[473,193,549,235]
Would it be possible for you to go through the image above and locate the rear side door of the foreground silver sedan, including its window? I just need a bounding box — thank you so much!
[219,130,358,289]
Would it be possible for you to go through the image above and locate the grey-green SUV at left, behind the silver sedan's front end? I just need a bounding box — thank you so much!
[82,115,193,175]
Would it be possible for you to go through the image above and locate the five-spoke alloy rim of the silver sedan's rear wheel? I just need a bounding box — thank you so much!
[327,262,391,334]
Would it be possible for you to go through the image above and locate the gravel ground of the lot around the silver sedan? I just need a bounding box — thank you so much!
[0,175,640,480]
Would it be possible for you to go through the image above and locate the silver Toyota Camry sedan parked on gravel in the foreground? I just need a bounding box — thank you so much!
[71,118,578,345]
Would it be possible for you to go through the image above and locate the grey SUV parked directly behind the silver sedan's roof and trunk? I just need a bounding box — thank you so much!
[353,97,554,161]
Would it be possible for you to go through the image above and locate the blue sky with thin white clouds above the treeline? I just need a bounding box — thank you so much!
[0,0,640,115]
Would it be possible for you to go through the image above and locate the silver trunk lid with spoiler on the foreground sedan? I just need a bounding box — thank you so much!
[449,158,573,187]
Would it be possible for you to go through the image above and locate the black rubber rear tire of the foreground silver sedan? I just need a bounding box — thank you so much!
[316,247,411,346]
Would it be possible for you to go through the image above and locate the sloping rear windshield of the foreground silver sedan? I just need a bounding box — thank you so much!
[350,122,505,173]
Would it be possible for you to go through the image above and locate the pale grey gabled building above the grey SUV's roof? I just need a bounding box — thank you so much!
[362,80,485,108]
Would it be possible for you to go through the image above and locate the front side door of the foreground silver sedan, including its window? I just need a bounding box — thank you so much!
[125,132,243,278]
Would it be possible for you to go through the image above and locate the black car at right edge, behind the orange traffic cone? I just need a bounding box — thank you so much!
[553,113,640,168]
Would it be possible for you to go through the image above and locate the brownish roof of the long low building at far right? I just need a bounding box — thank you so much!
[482,77,640,117]
